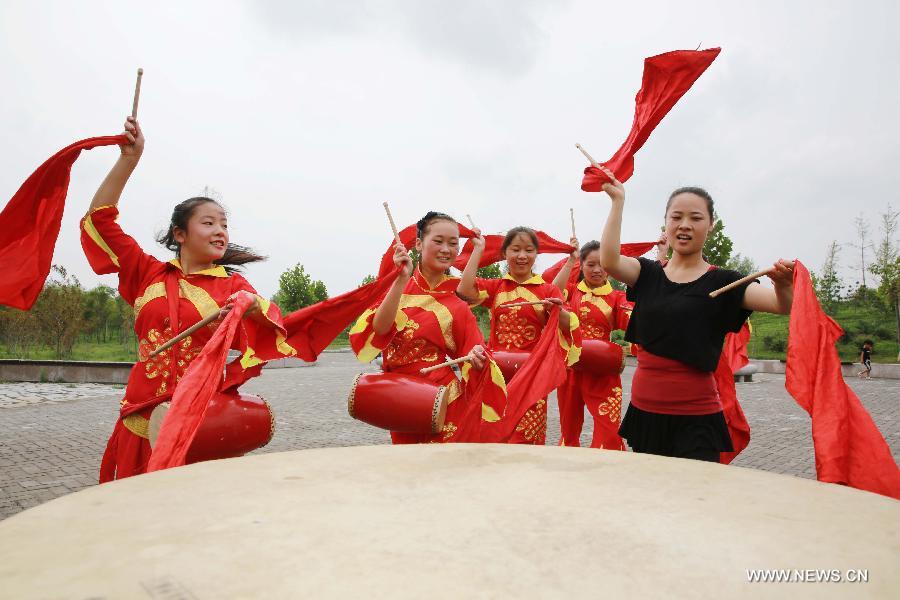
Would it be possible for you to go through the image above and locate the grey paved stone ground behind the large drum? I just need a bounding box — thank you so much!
[0,353,900,518]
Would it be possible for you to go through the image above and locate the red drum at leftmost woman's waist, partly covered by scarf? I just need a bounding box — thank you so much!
[149,393,275,463]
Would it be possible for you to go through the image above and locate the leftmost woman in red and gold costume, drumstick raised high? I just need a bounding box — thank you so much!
[81,117,294,483]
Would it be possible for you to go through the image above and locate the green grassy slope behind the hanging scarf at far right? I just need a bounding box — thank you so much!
[747,303,900,363]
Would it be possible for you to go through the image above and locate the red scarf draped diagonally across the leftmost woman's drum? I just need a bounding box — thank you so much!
[147,294,255,473]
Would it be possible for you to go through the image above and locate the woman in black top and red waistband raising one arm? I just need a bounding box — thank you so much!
[600,169,793,461]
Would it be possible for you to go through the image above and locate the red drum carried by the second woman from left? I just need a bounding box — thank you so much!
[347,373,450,434]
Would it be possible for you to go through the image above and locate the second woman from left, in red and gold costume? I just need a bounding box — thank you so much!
[350,212,505,444]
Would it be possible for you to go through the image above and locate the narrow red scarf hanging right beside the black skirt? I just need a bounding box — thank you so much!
[715,323,750,465]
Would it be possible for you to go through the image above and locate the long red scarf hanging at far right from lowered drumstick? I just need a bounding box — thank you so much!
[784,261,900,500]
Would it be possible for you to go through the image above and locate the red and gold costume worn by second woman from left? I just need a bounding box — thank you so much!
[350,268,506,444]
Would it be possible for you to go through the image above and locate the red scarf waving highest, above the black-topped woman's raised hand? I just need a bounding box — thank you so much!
[581,48,721,192]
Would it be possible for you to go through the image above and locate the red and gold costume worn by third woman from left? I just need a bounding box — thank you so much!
[473,274,580,445]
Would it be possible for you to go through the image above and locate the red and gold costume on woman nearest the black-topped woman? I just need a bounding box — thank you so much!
[556,280,632,450]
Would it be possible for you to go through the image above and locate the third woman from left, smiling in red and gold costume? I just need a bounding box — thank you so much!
[457,227,580,445]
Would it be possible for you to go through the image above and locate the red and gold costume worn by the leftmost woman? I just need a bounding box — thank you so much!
[81,206,295,483]
